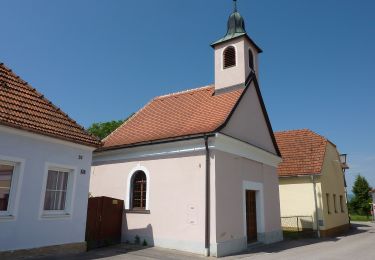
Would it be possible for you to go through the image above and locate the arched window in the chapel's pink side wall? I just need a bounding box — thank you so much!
[132,171,147,210]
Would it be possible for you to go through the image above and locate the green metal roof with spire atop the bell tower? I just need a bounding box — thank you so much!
[211,0,262,52]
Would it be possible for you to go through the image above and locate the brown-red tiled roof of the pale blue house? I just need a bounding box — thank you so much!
[0,63,100,147]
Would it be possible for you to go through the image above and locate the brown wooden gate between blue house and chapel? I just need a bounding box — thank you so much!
[86,197,124,249]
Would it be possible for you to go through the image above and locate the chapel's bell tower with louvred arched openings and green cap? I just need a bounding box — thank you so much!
[211,0,262,92]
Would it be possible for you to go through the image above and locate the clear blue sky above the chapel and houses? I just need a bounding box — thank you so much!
[0,0,375,191]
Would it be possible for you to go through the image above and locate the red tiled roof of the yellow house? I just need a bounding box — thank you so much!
[275,129,329,177]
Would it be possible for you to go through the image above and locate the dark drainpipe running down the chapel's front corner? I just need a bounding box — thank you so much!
[204,136,210,256]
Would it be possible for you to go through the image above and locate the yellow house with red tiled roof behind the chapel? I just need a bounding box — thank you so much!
[275,130,349,237]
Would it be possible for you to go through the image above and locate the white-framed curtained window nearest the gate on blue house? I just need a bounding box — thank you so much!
[43,169,71,212]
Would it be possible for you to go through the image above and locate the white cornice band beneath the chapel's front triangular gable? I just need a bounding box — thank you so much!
[213,133,282,167]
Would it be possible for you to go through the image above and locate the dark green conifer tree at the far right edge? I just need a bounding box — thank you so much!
[350,175,371,216]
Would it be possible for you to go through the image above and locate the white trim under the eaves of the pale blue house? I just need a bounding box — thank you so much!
[0,125,96,152]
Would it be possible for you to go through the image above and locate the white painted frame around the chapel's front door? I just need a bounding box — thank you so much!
[242,181,265,241]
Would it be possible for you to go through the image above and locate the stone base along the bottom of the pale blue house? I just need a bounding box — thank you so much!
[0,242,86,260]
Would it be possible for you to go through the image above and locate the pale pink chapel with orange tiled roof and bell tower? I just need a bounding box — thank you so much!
[90,2,282,256]
